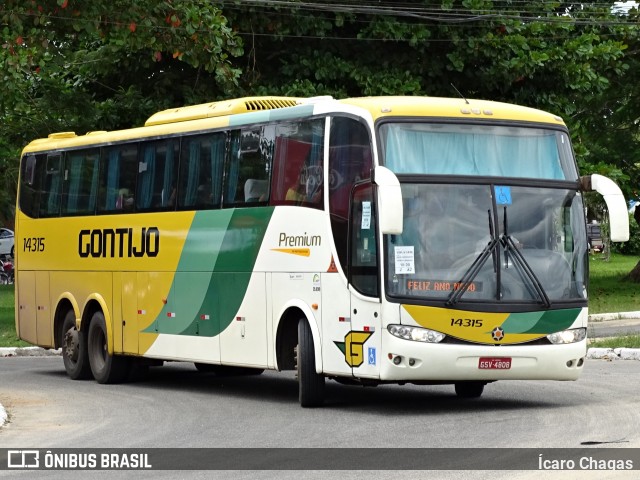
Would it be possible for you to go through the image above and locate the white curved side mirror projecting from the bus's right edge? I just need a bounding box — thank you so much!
[580,174,629,242]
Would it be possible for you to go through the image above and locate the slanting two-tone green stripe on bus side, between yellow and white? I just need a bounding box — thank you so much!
[144,207,273,337]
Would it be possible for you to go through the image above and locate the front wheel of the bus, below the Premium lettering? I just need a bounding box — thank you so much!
[296,318,324,407]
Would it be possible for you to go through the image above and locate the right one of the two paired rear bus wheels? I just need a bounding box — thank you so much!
[87,312,129,383]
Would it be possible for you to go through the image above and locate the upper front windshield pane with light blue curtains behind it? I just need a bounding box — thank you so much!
[379,122,578,180]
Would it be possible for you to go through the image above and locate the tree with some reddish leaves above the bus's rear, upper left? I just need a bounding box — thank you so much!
[0,0,242,225]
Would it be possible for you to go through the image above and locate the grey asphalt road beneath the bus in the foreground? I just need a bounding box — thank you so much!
[0,357,640,479]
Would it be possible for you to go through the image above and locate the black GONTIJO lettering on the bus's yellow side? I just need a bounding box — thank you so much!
[78,227,160,258]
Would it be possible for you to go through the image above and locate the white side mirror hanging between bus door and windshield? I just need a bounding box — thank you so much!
[372,167,404,235]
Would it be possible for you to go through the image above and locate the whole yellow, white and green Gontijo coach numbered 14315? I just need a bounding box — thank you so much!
[15,97,628,406]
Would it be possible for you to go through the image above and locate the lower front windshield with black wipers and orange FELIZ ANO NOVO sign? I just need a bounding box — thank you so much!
[385,183,587,308]
